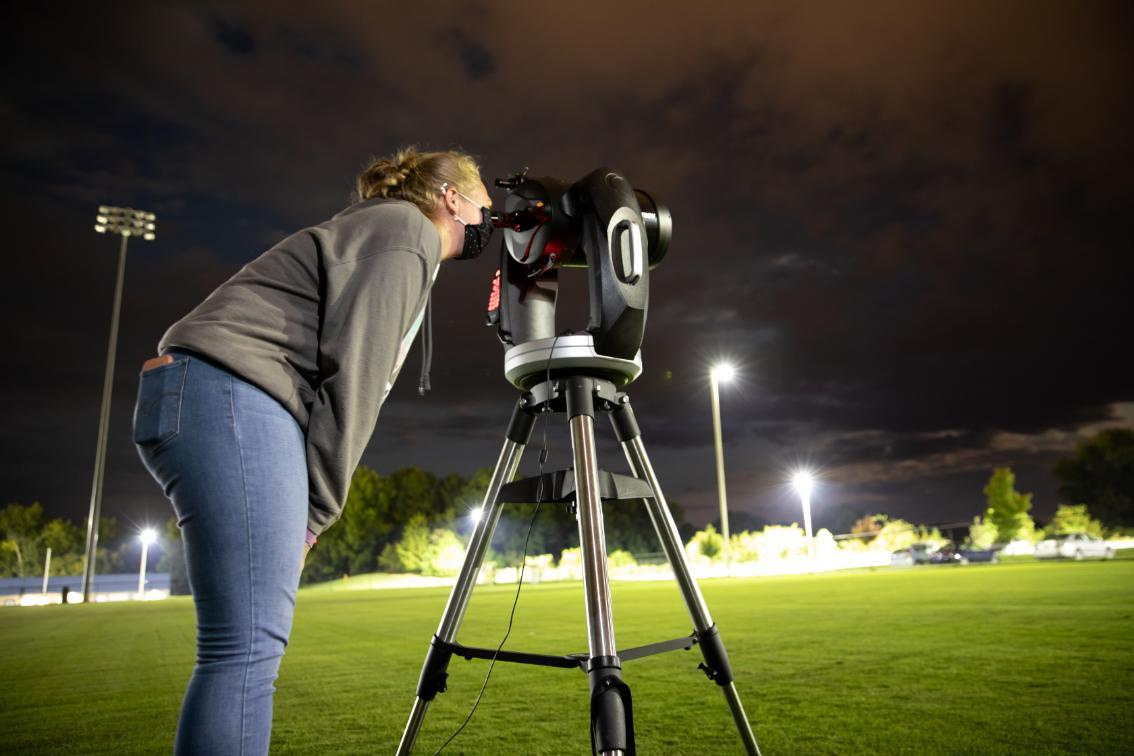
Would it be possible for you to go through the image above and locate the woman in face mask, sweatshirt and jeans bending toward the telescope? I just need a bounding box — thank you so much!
[134,147,492,755]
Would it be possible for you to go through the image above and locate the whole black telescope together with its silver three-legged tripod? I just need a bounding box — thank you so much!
[397,168,760,756]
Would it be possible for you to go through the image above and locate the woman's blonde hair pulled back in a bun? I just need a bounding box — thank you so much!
[355,146,481,216]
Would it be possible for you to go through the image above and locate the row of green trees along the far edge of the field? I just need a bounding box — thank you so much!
[0,428,1134,593]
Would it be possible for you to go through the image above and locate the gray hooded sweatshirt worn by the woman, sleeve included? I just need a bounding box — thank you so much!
[158,199,441,534]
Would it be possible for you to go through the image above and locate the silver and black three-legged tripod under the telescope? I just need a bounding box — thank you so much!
[397,355,760,756]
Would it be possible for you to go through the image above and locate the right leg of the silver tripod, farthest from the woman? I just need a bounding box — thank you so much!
[610,394,760,756]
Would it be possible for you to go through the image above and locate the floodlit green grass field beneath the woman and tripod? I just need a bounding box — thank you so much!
[0,560,1134,755]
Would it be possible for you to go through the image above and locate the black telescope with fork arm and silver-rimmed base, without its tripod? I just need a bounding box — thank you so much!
[488,168,674,390]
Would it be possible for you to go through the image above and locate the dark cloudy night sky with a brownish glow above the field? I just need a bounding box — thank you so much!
[0,5,1134,530]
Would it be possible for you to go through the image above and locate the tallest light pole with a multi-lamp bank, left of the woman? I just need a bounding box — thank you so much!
[83,205,156,603]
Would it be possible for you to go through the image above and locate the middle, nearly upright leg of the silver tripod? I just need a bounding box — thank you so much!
[567,377,634,755]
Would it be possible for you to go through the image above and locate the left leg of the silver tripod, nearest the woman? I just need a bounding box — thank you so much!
[397,399,535,756]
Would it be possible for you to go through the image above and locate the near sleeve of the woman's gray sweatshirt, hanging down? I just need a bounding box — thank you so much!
[307,248,431,535]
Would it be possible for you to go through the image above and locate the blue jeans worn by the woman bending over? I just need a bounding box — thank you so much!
[134,350,307,756]
